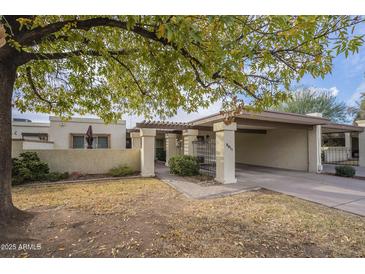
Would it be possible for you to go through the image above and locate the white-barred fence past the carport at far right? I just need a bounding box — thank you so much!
[322,147,359,166]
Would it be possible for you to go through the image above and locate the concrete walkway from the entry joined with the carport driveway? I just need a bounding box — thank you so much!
[156,165,365,216]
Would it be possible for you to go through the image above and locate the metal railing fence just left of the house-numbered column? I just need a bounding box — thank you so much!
[193,140,216,176]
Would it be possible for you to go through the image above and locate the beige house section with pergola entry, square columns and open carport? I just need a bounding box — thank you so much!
[130,111,365,183]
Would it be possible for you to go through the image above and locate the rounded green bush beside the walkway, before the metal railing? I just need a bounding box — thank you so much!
[169,155,199,176]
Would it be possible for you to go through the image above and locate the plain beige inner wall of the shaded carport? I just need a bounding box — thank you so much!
[236,129,308,171]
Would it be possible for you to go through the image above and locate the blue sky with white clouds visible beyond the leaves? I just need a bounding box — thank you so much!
[13,27,365,128]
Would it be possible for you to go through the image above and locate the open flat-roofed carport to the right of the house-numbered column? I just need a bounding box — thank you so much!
[194,111,328,172]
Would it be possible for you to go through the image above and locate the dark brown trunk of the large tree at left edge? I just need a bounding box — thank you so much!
[0,60,18,223]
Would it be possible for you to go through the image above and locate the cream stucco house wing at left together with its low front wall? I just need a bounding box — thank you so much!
[12,116,136,174]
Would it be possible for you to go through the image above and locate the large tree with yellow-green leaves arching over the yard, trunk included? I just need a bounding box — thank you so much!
[0,16,364,222]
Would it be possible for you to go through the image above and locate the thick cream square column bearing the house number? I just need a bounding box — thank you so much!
[213,122,237,184]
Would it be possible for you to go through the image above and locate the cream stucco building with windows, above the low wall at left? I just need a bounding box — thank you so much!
[12,116,126,150]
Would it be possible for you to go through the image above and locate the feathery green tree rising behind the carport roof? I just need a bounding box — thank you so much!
[275,87,346,122]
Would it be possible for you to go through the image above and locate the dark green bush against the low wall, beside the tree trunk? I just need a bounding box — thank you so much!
[12,152,68,185]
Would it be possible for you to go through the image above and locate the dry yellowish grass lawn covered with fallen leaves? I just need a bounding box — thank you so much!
[0,179,365,257]
